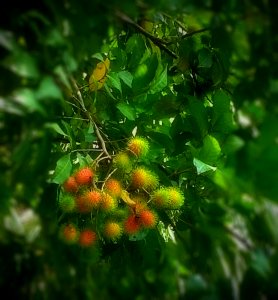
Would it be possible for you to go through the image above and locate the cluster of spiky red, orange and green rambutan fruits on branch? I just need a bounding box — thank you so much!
[57,137,184,248]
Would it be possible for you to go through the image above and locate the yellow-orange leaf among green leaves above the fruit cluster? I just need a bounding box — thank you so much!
[89,58,110,92]
